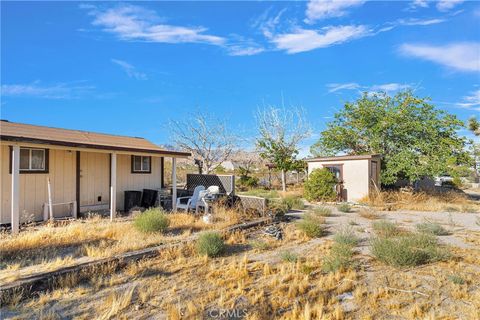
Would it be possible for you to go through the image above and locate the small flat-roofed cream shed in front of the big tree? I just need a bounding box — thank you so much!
[306,154,381,202]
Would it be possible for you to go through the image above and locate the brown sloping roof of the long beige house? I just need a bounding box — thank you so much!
[0,120,190,157]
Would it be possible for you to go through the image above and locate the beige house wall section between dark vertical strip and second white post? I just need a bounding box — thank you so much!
[80,152,110,212]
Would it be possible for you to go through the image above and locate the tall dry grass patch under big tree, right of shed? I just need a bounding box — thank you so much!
[360,191,480,212]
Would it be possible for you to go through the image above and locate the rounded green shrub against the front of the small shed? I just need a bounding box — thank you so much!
[304,168,337,201]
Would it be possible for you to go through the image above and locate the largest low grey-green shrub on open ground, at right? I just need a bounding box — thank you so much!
[372,233,448,267]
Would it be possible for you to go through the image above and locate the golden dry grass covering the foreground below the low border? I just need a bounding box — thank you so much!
[4,228,480,319]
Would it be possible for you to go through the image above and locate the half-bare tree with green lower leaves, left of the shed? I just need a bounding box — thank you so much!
[256,106,311,191]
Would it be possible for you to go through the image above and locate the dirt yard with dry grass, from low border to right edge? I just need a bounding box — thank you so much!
[1,199,480,319]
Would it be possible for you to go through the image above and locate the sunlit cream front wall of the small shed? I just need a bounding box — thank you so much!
[308,159,370,201]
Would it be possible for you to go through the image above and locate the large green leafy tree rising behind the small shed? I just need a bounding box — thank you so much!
[311,91,470,185]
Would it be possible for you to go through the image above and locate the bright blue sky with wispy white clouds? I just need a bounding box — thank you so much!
[1,0,480,154]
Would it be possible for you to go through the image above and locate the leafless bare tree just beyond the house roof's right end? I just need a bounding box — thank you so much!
[169,113,237,174]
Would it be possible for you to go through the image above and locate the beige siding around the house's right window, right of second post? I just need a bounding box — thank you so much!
[117,155,162,210]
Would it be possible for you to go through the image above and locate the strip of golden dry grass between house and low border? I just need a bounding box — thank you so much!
[0,208,242,282]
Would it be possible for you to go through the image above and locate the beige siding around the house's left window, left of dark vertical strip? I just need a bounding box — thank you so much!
[0,145,75,223]
